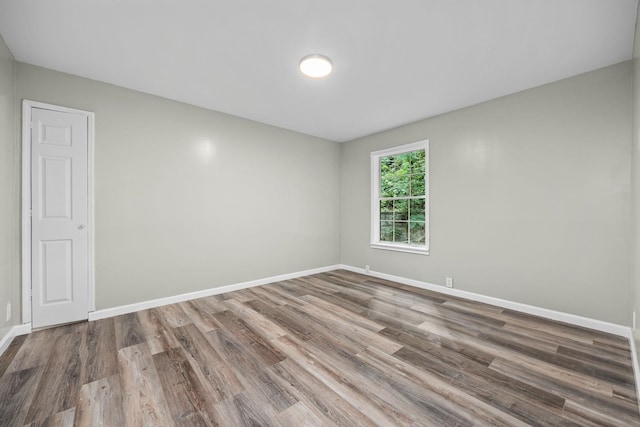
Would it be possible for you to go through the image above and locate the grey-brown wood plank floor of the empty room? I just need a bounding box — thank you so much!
[0,270,640,427]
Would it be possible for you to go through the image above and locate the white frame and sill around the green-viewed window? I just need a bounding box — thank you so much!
[370,139,431,255]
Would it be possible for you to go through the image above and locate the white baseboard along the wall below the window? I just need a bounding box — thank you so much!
[340,265,631,337]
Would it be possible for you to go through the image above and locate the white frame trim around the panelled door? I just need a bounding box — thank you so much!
[21,99,96,324]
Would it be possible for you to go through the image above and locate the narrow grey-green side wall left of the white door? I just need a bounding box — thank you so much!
[0,37,20,338]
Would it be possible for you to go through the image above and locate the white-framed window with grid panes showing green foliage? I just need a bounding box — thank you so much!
[371,140,429,255]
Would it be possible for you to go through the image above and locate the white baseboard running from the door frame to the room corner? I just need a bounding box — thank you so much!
[89,265,341,321]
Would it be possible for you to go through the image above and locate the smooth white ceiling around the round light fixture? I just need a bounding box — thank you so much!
[0,0,638,141]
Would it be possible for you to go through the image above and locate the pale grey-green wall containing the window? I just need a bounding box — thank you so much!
[340,62,632,325]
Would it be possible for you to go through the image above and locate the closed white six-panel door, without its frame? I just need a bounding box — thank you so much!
[31,107,89,328]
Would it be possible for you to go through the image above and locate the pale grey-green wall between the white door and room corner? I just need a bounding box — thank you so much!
[17,63,340,309]
